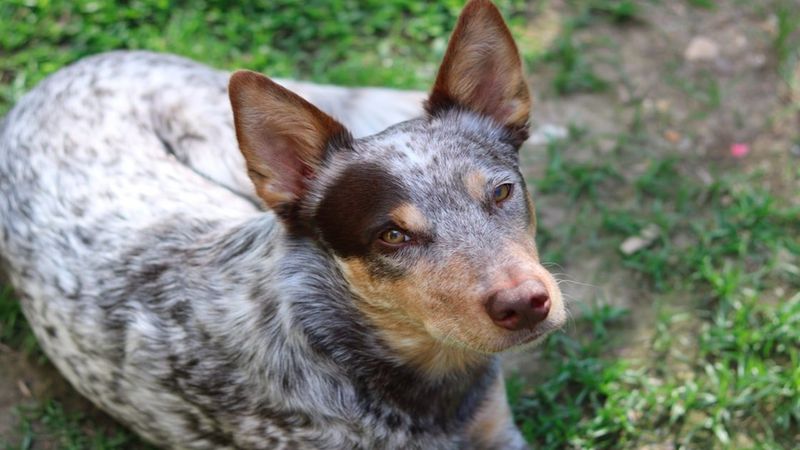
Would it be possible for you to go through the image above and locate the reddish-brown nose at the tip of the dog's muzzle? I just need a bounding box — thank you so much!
[485,280,550,331]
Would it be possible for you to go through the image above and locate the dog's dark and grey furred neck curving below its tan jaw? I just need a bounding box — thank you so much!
[279,225,499,425]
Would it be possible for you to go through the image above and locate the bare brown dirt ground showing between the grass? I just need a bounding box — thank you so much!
[0,1,800,449]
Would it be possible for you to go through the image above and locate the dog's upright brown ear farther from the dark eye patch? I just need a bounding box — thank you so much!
[425,0,531,143]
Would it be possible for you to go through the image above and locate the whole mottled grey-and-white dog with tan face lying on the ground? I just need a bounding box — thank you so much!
[0,0,565,449]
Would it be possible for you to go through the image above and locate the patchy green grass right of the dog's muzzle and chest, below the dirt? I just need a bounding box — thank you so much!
[511,160,800,449]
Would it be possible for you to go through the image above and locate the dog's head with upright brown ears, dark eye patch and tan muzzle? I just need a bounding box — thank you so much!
[230,0,565,369]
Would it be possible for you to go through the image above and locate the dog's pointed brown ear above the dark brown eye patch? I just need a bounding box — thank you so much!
[228,71,352,218]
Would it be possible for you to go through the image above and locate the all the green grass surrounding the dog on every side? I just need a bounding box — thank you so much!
[0,0,800,449]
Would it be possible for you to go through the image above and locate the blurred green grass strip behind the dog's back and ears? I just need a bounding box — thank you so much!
[0,0,525,112]
